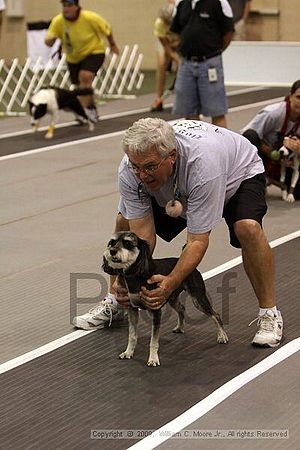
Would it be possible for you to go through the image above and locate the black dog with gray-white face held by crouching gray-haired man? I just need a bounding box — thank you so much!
[102,231,228,366]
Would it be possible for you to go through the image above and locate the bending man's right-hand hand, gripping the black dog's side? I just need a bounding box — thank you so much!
[140,275,174,309]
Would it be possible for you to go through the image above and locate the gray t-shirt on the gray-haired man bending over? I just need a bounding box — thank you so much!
[119,120,264,234]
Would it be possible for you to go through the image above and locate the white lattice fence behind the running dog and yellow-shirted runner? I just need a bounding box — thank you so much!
[0,45,144,115]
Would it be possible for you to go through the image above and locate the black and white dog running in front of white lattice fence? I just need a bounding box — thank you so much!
[29,87,97,139]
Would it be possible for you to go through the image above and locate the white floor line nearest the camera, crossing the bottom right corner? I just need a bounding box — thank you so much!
[128,338,300,450]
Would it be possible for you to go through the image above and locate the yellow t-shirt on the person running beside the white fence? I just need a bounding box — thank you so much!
[46,10,112,64]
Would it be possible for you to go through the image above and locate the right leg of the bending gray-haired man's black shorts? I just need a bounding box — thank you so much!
[223,173,268,248]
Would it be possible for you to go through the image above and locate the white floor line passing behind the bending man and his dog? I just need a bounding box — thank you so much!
[0,230,300,375]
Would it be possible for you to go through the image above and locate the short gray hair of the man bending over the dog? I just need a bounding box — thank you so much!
[122,117,176,157]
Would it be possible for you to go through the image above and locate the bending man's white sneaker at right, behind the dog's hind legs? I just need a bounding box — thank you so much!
[249,309,283,347]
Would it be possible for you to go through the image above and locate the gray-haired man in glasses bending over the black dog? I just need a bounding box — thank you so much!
[73,118,283,347]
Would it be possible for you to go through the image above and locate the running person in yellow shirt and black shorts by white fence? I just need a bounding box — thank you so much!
[45,0,119,121]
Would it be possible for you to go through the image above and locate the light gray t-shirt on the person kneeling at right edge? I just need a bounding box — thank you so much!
[241,101,300,147]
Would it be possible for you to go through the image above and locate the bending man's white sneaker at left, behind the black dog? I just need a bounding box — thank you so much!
[73,297,124,330]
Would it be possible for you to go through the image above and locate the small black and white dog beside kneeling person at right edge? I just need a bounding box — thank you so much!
[279,145,300,203]
